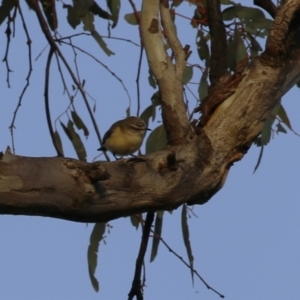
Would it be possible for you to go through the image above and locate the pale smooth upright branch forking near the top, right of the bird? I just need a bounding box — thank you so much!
[141,0,194,145]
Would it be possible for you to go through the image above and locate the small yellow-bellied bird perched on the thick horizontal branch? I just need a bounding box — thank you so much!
[98,117,151,158]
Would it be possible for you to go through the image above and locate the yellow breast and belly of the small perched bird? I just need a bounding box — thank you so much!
[104,127,144,156]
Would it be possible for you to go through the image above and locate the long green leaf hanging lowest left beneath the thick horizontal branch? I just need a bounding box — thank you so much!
[87,223,106,292]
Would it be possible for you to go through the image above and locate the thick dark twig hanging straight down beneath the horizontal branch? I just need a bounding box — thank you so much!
[128,212,154,300]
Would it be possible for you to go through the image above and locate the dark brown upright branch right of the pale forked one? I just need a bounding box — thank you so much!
[206,0,227,85]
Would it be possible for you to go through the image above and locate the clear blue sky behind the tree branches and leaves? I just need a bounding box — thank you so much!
[0,1,300,300]
